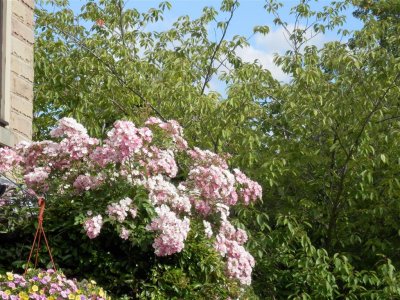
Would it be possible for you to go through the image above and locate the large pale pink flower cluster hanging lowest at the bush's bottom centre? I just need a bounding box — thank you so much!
[147,204,190,256]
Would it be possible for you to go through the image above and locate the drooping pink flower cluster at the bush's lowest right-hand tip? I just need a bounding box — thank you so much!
[214,221,255,285]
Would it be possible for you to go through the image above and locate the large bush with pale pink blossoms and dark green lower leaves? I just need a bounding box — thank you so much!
[0,118,261,299]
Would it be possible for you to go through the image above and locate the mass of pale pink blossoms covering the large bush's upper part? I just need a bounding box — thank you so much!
[0,118,262,292]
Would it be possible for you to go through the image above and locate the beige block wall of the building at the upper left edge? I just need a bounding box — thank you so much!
[0,0,34,146]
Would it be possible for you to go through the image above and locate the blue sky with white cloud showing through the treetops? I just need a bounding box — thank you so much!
[45,0,361,85]
